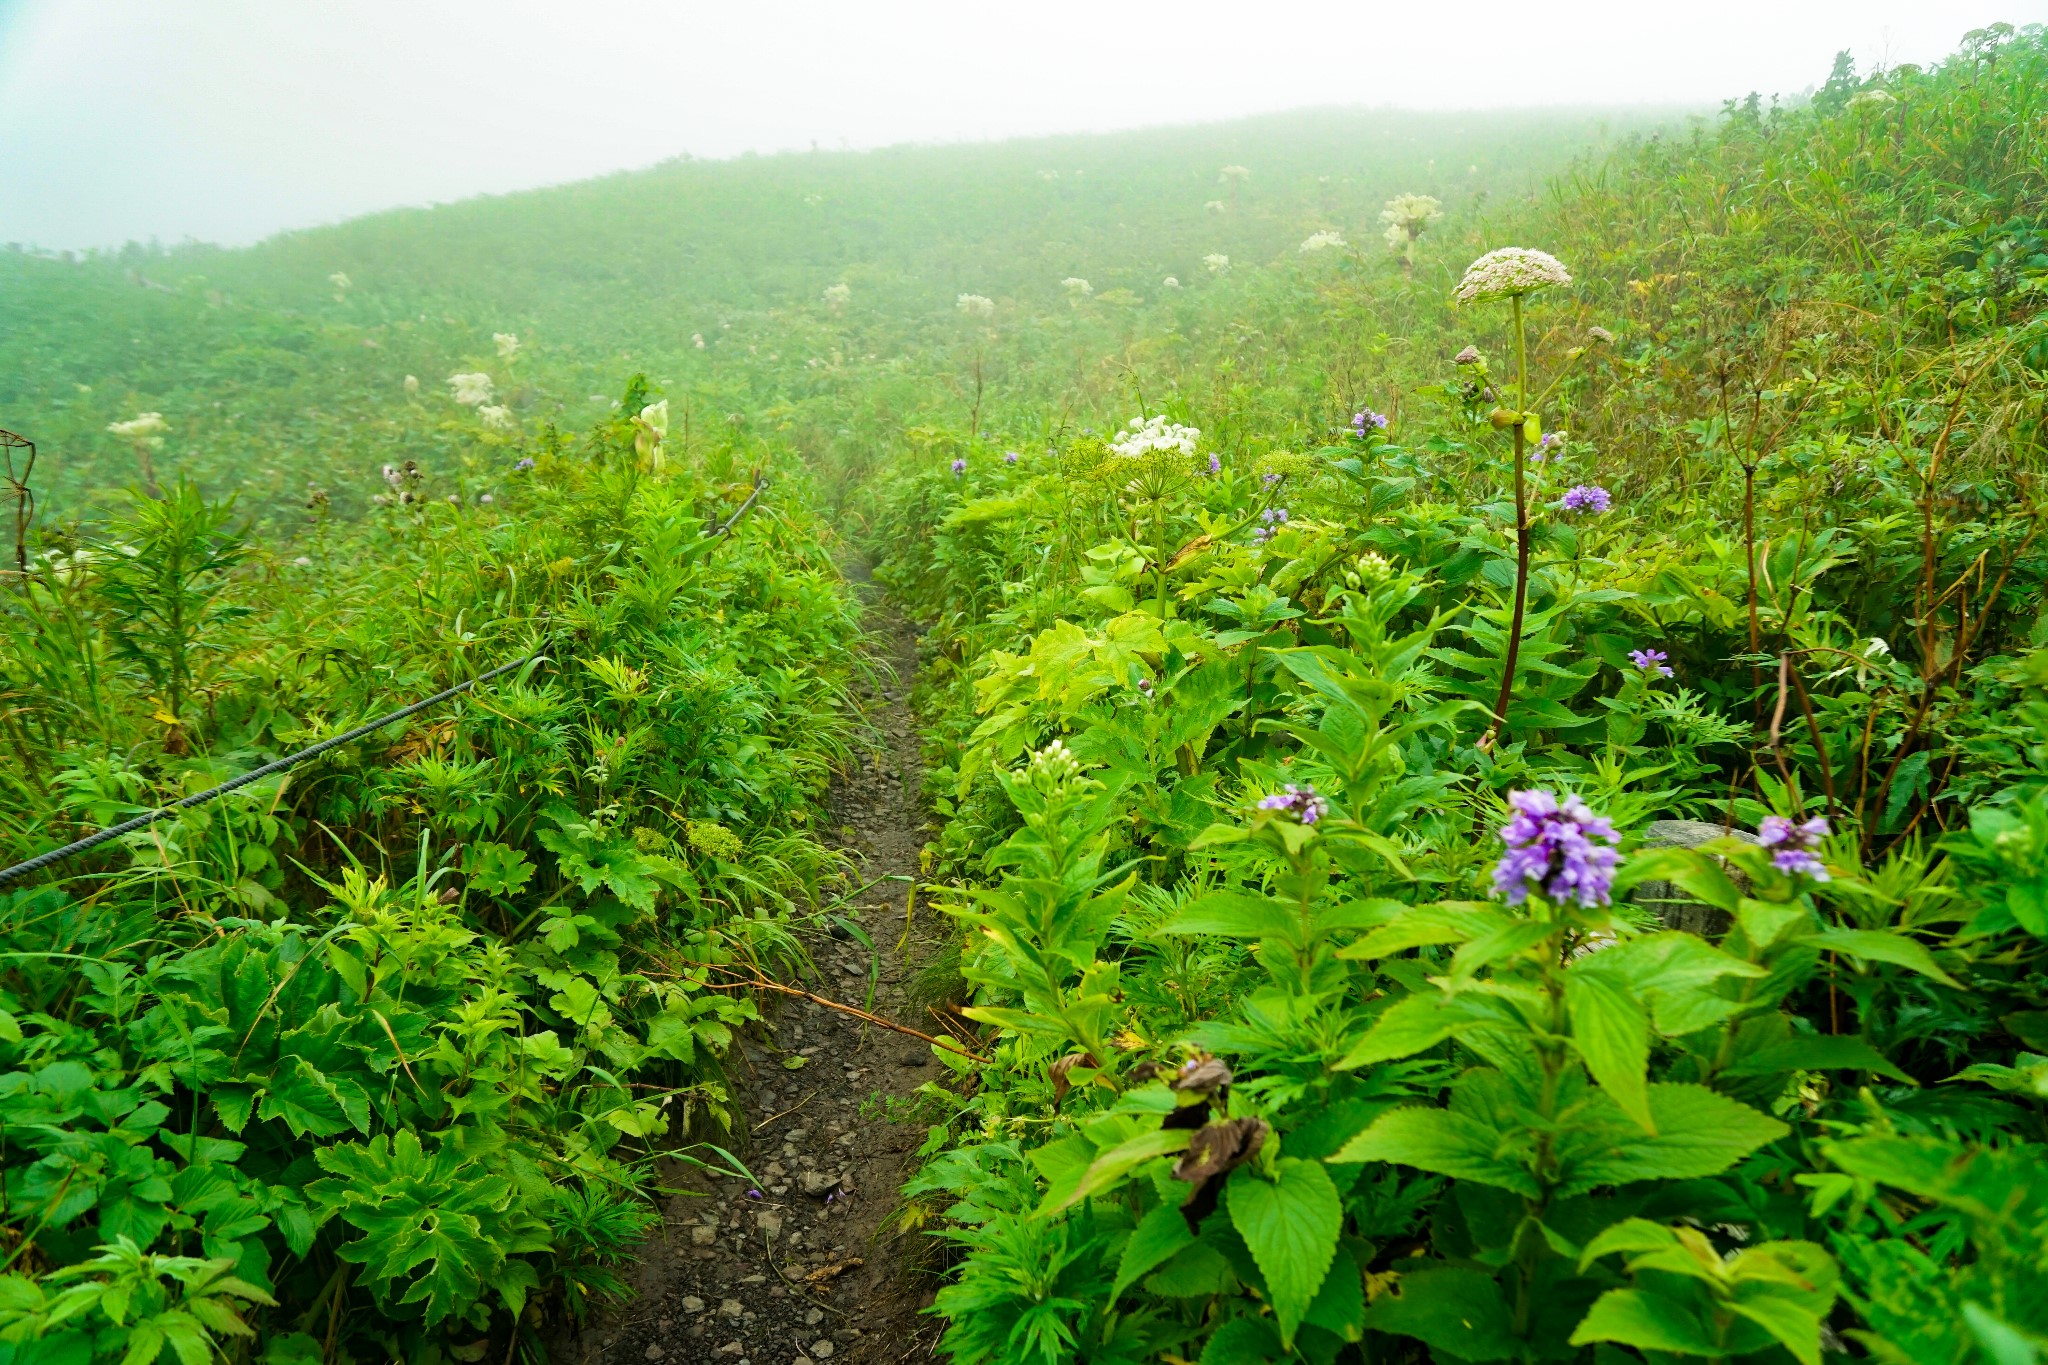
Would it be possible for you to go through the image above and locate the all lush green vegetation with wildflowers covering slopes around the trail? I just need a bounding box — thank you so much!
[0,18,2048,1365]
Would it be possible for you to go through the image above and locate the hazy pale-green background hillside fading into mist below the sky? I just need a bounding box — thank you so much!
[0,113,1645,514]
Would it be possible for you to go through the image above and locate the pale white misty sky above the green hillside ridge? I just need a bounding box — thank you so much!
[0,0,2048,248]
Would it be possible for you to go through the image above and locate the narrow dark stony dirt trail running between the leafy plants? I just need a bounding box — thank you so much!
[565,569,942,1365]
